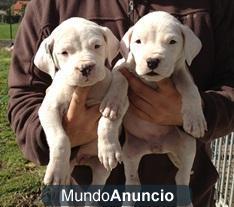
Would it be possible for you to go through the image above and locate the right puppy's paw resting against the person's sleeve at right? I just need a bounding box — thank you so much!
[183,109,207,138]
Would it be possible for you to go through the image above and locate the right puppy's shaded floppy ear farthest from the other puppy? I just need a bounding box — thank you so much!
[181,25,202,66]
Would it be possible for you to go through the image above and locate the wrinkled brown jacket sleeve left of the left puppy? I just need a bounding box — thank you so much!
[8,0,79,164]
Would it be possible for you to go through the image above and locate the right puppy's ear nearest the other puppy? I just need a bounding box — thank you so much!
[120,27,133,59]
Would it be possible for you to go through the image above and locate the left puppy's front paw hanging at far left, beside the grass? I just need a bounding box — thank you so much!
[44,159,71,185]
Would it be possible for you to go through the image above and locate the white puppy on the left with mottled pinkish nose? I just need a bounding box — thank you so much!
[34,17,128,184]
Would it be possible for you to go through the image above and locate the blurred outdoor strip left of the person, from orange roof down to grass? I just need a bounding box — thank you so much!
[0,0,44,207]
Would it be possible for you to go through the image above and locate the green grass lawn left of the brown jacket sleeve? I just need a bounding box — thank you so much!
[0,49,44,207]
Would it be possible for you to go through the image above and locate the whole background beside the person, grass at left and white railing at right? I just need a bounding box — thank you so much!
[0,0,234,207]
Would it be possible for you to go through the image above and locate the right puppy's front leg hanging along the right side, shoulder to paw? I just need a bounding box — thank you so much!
[173,68,207,138]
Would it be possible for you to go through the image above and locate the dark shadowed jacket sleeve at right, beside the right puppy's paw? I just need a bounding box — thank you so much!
[200,0,234,141]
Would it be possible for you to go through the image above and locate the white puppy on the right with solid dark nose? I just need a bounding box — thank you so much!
[104,12,206,205]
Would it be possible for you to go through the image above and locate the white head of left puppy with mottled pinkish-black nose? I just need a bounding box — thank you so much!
[34,17,119,87]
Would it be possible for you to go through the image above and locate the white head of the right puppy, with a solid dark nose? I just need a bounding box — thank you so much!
[120,12,201,81]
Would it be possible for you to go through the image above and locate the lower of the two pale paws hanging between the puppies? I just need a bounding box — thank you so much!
[98,138,122,171]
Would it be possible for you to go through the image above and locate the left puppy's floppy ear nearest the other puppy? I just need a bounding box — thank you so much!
[102,27,119,65]
